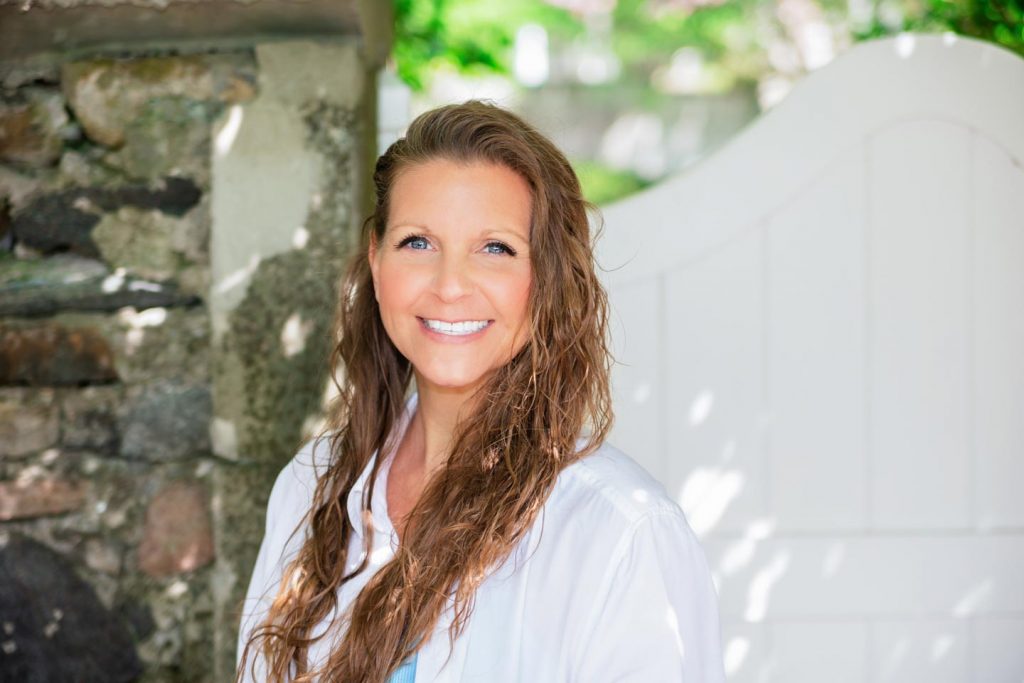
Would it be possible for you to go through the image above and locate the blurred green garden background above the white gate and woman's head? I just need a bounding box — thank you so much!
[389,0,1024,204]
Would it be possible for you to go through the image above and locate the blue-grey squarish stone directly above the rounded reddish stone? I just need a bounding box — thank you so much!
[119,382,213,462]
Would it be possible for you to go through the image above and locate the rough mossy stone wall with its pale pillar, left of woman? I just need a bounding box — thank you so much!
[0,41,374,682]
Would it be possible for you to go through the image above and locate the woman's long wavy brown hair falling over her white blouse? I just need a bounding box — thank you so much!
[238,101,612,683]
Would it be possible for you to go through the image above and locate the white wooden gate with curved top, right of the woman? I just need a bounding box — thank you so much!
[599,35,1024,683]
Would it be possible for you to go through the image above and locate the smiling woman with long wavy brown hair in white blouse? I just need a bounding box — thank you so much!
[239,101,723,683]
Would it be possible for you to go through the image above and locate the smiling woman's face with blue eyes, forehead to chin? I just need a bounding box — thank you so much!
[370,160,531,401]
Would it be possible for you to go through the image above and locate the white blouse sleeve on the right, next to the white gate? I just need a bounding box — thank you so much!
[573,512,725,683]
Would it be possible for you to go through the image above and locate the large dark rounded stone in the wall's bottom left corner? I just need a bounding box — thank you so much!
[0,535,142,683]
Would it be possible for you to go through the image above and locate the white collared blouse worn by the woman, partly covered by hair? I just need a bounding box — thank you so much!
[239,394,725,683]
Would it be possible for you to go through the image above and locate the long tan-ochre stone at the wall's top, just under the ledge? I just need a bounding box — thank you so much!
[61,56,253,147]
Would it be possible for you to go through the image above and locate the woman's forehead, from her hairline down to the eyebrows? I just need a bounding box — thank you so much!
[388,159,532,233]
